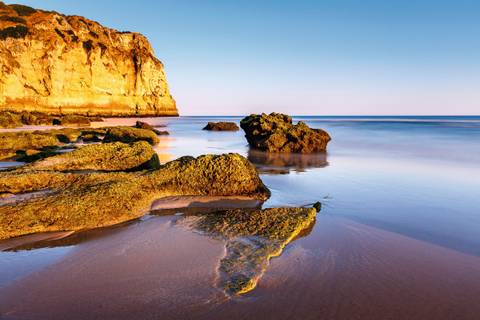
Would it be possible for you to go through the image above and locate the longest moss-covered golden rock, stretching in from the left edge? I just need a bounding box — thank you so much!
[0,154,269,239]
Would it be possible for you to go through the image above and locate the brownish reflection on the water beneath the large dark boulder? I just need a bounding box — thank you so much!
[248,149,328,174]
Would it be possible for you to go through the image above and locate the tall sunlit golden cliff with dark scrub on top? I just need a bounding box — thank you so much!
[0,2,178,116]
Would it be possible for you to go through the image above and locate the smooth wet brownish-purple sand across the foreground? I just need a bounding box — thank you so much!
[0,215,480,319]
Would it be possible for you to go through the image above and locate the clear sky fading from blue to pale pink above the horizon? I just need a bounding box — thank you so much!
[8,0,480,115]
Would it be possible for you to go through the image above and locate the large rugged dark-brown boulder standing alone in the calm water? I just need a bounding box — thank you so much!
[240,113,331,153]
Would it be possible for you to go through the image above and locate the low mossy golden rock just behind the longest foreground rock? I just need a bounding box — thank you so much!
[23,141,160,171]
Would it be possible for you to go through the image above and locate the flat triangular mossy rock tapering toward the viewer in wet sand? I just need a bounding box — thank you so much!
[187,208,317,294]
